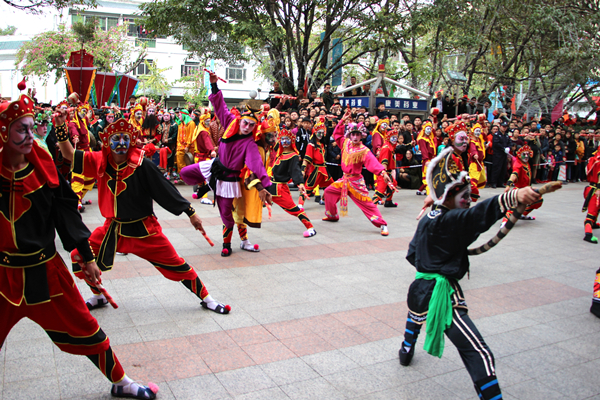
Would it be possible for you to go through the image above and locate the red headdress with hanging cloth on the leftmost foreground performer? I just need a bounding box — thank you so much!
[0,94,59,187]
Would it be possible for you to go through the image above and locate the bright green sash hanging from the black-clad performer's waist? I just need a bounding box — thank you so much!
[416,272,454,358]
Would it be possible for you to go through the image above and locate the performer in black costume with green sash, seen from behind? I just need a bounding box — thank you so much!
[399,147,541,400]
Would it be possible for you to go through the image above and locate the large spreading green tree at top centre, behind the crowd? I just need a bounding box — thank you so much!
[141,0,403,93]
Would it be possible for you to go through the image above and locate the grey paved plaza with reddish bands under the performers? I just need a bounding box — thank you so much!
[0,183,600,400]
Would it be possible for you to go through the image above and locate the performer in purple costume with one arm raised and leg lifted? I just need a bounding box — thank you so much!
[181,73,271,257]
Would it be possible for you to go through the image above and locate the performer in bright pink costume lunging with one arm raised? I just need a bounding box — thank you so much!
[323,110,392,236]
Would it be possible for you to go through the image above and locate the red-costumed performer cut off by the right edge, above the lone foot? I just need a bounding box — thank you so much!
[581,147,600,244]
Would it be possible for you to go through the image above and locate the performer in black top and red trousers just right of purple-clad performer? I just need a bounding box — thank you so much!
[267,129,317,238]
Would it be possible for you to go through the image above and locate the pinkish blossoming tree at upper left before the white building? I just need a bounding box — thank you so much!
[15,25,147,82]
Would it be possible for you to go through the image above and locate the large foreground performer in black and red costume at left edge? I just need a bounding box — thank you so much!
[0,95,156,399]
